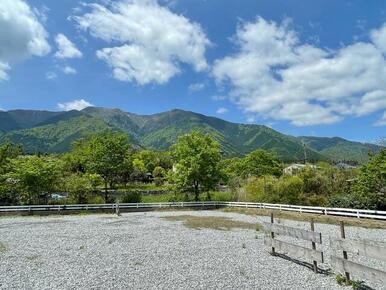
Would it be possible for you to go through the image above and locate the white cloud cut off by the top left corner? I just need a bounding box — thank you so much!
[0,0,51,81]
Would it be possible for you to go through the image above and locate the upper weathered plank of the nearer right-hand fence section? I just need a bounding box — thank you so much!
[330,238,386,262]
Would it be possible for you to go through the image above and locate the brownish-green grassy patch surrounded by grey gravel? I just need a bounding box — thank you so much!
[162,215,260,231]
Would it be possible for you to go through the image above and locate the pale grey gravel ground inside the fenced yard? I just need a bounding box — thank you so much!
[0,211,386,290]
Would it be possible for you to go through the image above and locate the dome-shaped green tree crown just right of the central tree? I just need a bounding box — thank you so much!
[240,149,283,178]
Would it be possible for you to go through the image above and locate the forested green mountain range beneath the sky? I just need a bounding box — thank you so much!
[0,107,381,163]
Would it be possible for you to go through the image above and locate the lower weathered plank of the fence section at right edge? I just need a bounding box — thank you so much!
[331,256,386,285]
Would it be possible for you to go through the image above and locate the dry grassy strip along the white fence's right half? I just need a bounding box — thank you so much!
[222,208,386,229]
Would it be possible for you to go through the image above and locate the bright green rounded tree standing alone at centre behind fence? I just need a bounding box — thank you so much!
[171,131,222,201]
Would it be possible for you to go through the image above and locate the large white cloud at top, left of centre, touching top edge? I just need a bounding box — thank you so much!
[73,0,210,85]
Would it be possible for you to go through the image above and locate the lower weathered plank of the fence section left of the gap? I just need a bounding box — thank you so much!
[264,237,324,263]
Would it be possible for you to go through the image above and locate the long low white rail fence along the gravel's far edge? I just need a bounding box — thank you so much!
[0,201,386,220]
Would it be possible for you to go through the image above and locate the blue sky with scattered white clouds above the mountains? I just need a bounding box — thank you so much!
[0,0,386,142]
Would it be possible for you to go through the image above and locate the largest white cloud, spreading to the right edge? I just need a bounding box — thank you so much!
[213,17,386,126]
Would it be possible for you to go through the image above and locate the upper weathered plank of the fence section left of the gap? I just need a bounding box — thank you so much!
[262,222,322,244]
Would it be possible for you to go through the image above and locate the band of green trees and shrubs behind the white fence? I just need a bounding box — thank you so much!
[0,131,386,210]
